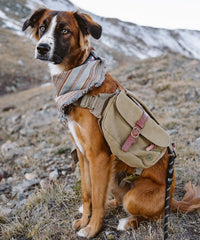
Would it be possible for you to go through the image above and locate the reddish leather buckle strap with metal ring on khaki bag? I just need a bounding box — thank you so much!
[122,112,148,152]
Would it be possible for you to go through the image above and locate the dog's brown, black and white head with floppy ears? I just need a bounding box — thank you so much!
[22,8,102,64]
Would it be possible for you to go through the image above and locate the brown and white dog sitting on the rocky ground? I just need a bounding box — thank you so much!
[22,9,200,238]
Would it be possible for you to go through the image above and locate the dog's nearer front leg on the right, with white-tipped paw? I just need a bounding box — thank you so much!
[78,151,115,238]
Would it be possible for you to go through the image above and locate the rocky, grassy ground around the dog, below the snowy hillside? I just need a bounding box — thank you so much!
[0,54,200,240]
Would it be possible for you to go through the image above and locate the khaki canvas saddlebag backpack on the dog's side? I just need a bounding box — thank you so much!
[100,91,169,168]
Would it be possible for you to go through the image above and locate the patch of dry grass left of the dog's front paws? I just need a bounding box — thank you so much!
[1,183,80,240]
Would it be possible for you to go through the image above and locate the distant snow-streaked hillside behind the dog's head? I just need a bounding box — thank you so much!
[0,0,200,95]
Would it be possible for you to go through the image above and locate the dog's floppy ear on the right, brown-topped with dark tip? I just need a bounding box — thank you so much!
[74,12,102,39]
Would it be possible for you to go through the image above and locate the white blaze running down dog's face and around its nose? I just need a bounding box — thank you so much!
[35,16,57,59]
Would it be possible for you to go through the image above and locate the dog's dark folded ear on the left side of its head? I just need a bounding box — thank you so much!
[22,8,47,31]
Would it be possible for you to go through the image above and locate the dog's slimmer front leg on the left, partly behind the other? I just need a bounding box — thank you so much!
[73,150,91,230]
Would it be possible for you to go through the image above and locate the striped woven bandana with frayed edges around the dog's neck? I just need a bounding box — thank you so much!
[53,59,105,112]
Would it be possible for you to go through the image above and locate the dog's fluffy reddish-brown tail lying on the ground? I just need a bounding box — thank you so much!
[170,182,200,213]
